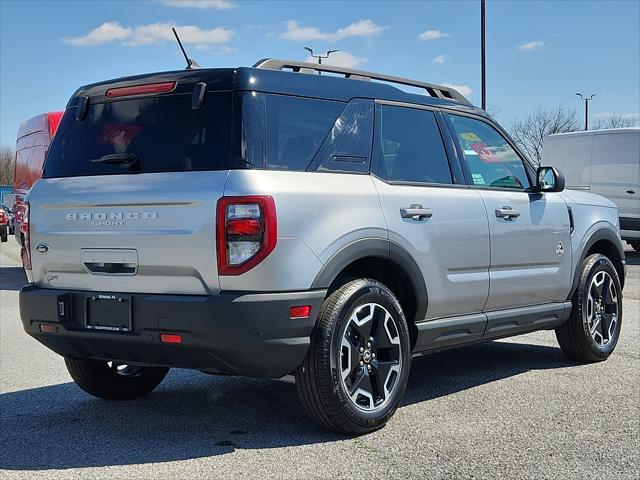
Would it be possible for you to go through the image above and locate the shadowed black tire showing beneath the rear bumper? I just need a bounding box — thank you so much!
[64,358,169,400]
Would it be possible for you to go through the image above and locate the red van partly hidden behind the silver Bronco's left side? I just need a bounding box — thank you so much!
[13,112,64,245]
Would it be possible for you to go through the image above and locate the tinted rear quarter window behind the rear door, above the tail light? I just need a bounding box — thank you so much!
[266,95,344,171]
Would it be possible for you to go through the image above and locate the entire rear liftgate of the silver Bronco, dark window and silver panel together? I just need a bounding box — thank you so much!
[29,70,234,294]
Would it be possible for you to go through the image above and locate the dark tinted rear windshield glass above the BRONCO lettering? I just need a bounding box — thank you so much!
[44,93,232,177]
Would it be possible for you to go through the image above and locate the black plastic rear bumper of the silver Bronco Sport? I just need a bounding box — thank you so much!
[20,285,326,378]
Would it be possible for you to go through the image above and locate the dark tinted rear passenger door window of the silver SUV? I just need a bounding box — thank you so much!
[376,105,452,183]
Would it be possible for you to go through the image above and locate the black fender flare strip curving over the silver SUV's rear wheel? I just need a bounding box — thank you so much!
[311,238,428,322]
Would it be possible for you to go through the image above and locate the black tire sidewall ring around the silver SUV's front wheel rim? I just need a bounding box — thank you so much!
[579,255,622,358]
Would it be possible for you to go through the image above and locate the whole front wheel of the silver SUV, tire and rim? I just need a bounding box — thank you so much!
[556,254,622,363]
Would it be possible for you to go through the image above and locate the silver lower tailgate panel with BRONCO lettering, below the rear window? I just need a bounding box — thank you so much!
[30,171,227,294]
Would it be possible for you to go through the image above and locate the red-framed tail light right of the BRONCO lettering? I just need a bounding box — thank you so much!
[216,195,278,275]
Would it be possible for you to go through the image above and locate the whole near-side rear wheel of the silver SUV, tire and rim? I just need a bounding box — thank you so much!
[295,279,411,434]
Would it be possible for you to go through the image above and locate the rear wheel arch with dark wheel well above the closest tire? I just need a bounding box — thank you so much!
[312,238,428,348]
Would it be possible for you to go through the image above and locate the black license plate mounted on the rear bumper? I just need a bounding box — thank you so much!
[86,293,131,332]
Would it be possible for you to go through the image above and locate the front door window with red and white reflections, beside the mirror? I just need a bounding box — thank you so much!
[450,115,530,189]
